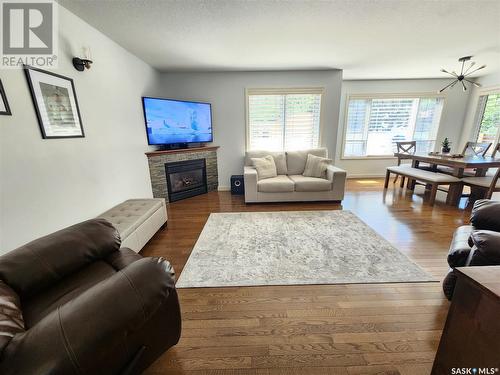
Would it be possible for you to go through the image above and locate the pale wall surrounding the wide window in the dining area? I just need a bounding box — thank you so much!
[335,79,469,177]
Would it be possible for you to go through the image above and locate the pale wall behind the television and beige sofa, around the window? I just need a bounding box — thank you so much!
[161,70,342,189]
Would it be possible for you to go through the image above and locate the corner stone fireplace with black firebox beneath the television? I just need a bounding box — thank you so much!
[146,146,218,202]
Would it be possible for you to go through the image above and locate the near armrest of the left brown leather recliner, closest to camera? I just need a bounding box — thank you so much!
[0,258,180,375]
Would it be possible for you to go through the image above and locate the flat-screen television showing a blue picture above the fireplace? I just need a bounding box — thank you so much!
[142,97,212,145]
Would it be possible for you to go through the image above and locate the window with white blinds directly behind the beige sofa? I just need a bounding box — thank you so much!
[247,89,323,151]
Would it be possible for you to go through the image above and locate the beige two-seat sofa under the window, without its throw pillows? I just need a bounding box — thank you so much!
[244,148,346,203]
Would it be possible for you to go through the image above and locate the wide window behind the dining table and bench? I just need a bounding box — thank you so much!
[343,96,444,158]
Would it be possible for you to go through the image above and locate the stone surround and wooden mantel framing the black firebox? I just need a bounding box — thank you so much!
[146,146,219,202]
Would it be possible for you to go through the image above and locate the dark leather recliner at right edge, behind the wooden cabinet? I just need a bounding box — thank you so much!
[443,199,500,300]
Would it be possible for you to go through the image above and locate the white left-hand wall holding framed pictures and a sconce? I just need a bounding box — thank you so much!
[0,7,158,253]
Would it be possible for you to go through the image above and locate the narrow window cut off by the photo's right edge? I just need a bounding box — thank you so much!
[474,93,500,150]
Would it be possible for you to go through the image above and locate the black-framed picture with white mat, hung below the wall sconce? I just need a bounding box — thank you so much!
[24,65,85,139]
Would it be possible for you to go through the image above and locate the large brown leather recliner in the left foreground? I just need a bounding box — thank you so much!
[0,219,181,375]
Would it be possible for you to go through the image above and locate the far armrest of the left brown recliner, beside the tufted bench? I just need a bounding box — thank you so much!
[0,219,121,298]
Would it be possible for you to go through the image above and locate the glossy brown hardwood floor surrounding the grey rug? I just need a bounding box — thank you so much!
[142,179,469,375]
